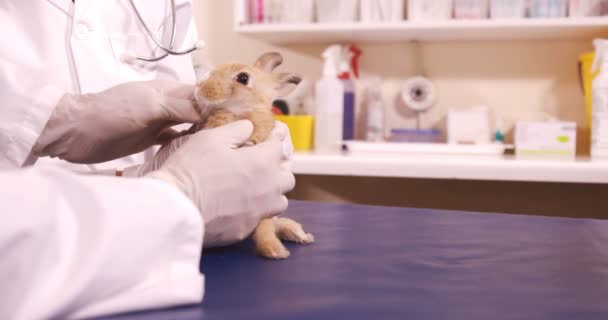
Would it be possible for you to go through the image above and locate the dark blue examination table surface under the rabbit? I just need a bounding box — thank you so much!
[102,201,608,320]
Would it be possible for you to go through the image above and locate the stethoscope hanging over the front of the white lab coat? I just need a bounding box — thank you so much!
[122,0,205,62]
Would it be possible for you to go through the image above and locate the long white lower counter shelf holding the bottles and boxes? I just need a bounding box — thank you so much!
[293,152,608,184]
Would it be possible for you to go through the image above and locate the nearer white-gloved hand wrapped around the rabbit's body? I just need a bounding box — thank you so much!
[146,120,295,247]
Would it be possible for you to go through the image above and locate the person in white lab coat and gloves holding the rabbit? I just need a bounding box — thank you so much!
[0,0,294,319]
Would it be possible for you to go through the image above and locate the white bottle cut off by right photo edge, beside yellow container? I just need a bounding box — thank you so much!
[591,39,608,159]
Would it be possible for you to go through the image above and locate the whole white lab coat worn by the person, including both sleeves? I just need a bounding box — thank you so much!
[0,0,203,319]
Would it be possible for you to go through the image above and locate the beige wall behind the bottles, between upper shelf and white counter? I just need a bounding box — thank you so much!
[195,0,592,142]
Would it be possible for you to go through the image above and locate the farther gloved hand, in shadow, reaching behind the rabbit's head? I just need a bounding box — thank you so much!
[32,80,206,164]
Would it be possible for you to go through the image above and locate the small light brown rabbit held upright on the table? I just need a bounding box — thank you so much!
[193,52,314,259]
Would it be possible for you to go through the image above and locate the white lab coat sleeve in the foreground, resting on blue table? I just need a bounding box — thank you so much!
[0,167,204,319]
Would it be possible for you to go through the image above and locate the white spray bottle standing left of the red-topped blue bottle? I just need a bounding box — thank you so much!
[315,45,344,151]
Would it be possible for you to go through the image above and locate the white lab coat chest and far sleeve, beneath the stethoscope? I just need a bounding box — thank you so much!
[0,0,197,171]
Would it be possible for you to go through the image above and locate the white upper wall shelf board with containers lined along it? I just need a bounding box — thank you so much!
[236,17,608,44]
